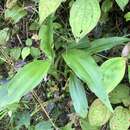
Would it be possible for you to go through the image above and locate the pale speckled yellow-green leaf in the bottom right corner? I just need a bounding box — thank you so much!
[110,106,130,130]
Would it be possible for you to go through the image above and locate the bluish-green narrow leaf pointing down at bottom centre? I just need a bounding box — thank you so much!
[69,75,88,118]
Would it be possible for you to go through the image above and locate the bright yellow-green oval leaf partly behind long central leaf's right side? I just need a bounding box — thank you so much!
[101,57,126,93]
